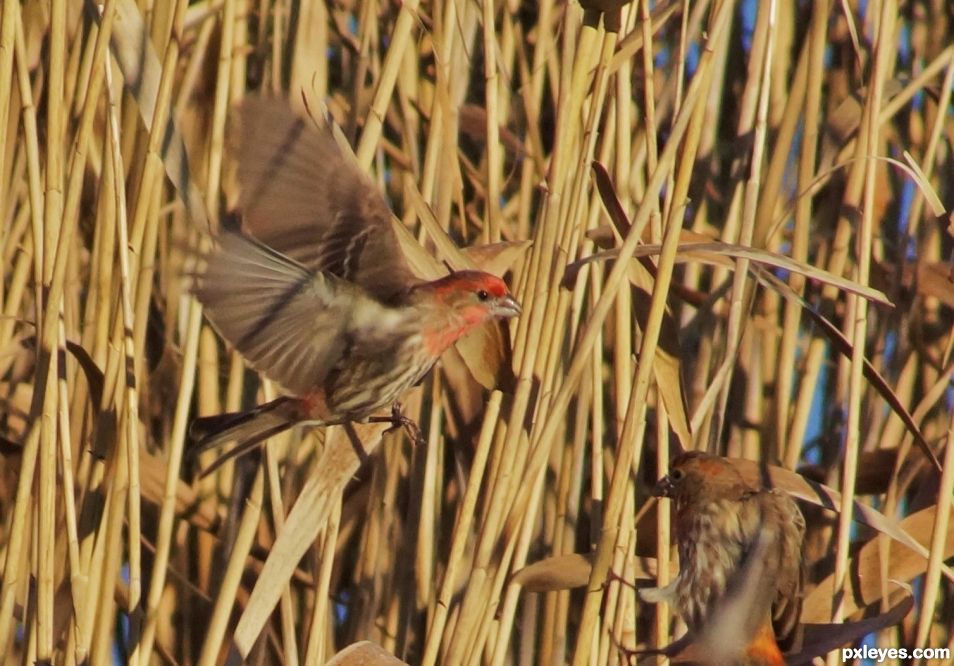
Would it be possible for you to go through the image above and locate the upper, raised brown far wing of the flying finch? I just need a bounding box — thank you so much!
[233,96,414,301]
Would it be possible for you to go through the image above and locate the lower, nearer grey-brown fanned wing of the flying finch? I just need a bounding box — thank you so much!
[195,232,358,395]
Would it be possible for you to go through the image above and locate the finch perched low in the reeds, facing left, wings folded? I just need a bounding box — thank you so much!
[641,451,805,665]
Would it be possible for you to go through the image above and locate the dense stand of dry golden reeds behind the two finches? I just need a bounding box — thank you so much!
[0,0,954,666]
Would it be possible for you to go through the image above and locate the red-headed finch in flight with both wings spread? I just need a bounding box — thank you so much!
[191,97,520,464]
